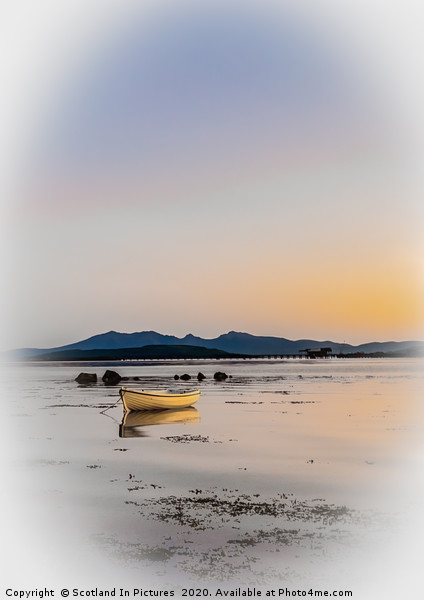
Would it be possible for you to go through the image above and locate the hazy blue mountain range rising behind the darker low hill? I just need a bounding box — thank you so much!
[6,331,424,360]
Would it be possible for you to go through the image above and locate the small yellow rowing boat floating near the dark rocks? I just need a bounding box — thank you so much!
[119,388,200,412]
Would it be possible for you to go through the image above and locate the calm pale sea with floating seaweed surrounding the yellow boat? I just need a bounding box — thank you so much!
[3,359,424,599]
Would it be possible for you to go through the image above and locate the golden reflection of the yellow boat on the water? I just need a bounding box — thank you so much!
[119,407,200,438]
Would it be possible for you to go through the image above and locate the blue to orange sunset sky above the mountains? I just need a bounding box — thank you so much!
[2,0,424,347]
